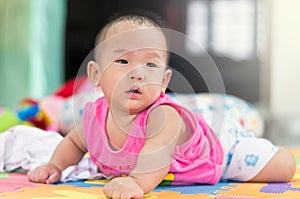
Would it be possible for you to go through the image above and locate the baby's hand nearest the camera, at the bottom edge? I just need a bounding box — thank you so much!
[103,177,144,199]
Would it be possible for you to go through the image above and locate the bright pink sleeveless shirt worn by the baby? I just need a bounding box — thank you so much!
[83,94,223,185]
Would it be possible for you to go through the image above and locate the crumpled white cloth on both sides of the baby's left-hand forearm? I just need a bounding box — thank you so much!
[0,125,105,182]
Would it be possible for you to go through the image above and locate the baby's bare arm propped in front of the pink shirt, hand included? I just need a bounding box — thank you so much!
[104,105,184,198]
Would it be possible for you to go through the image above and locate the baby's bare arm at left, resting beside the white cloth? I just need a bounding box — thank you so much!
[27,128,87,184]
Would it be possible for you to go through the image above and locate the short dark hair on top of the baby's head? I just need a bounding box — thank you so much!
[95,9,165,46]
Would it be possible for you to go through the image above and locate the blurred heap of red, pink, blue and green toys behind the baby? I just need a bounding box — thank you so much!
[0,76,93,134]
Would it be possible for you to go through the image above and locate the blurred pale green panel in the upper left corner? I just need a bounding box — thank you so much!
[0,0,67,107]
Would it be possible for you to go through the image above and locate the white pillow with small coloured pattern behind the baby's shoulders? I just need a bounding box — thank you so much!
[59,91,264,137]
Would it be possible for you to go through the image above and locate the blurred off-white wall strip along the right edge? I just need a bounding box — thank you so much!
[270,0,300,116]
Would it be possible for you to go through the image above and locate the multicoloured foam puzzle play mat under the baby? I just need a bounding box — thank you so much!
[0,149,300,199]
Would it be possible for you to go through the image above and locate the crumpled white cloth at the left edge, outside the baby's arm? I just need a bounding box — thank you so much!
[0,125,63,172]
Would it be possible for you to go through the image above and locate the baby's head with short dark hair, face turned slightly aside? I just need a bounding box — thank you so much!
[88,9,172,113]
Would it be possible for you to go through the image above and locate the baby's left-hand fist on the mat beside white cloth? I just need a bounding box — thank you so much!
[27,164,61,184]
